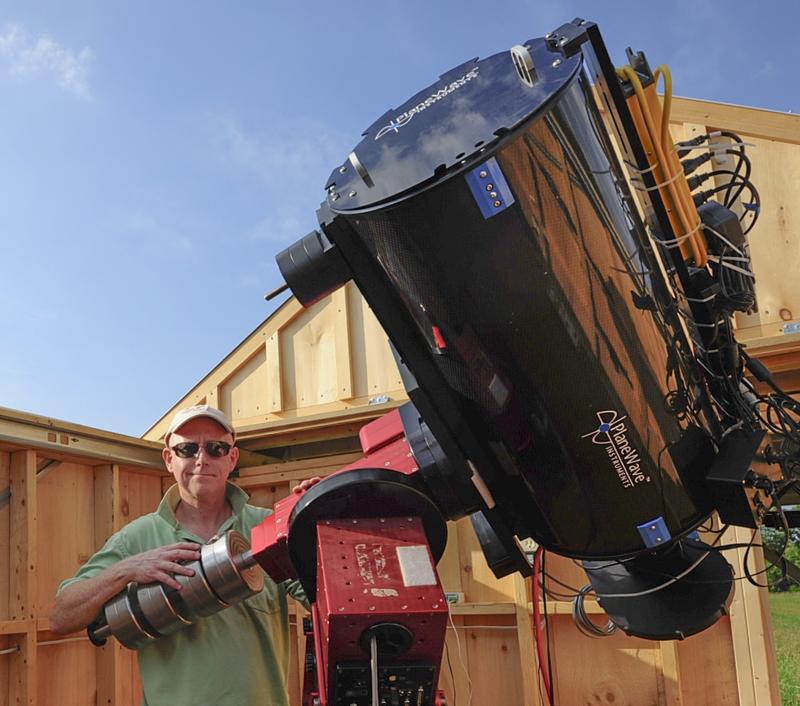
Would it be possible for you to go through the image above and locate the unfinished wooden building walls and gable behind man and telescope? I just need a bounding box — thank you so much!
[0,99,800,706]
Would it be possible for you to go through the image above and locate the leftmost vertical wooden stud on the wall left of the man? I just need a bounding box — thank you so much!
[8,450,36,706]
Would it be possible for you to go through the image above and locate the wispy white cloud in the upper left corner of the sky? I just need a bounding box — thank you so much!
[0,23,92,99]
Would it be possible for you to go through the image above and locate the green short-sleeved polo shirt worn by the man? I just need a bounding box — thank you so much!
[59,483,305,706]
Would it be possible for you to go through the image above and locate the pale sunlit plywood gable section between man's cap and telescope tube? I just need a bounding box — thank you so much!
[145,283,407,440]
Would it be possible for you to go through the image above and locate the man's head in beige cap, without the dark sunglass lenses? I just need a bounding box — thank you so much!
[162,417,239,499]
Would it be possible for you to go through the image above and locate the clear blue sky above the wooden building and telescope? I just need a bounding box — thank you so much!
[0,0,800,435]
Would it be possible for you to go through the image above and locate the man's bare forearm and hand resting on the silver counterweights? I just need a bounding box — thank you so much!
[50,542,200,635]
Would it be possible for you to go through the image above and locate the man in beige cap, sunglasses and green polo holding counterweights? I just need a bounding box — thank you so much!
[50,405,319,706]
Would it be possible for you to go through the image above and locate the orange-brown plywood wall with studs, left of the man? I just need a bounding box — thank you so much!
[0,447,163,706]
